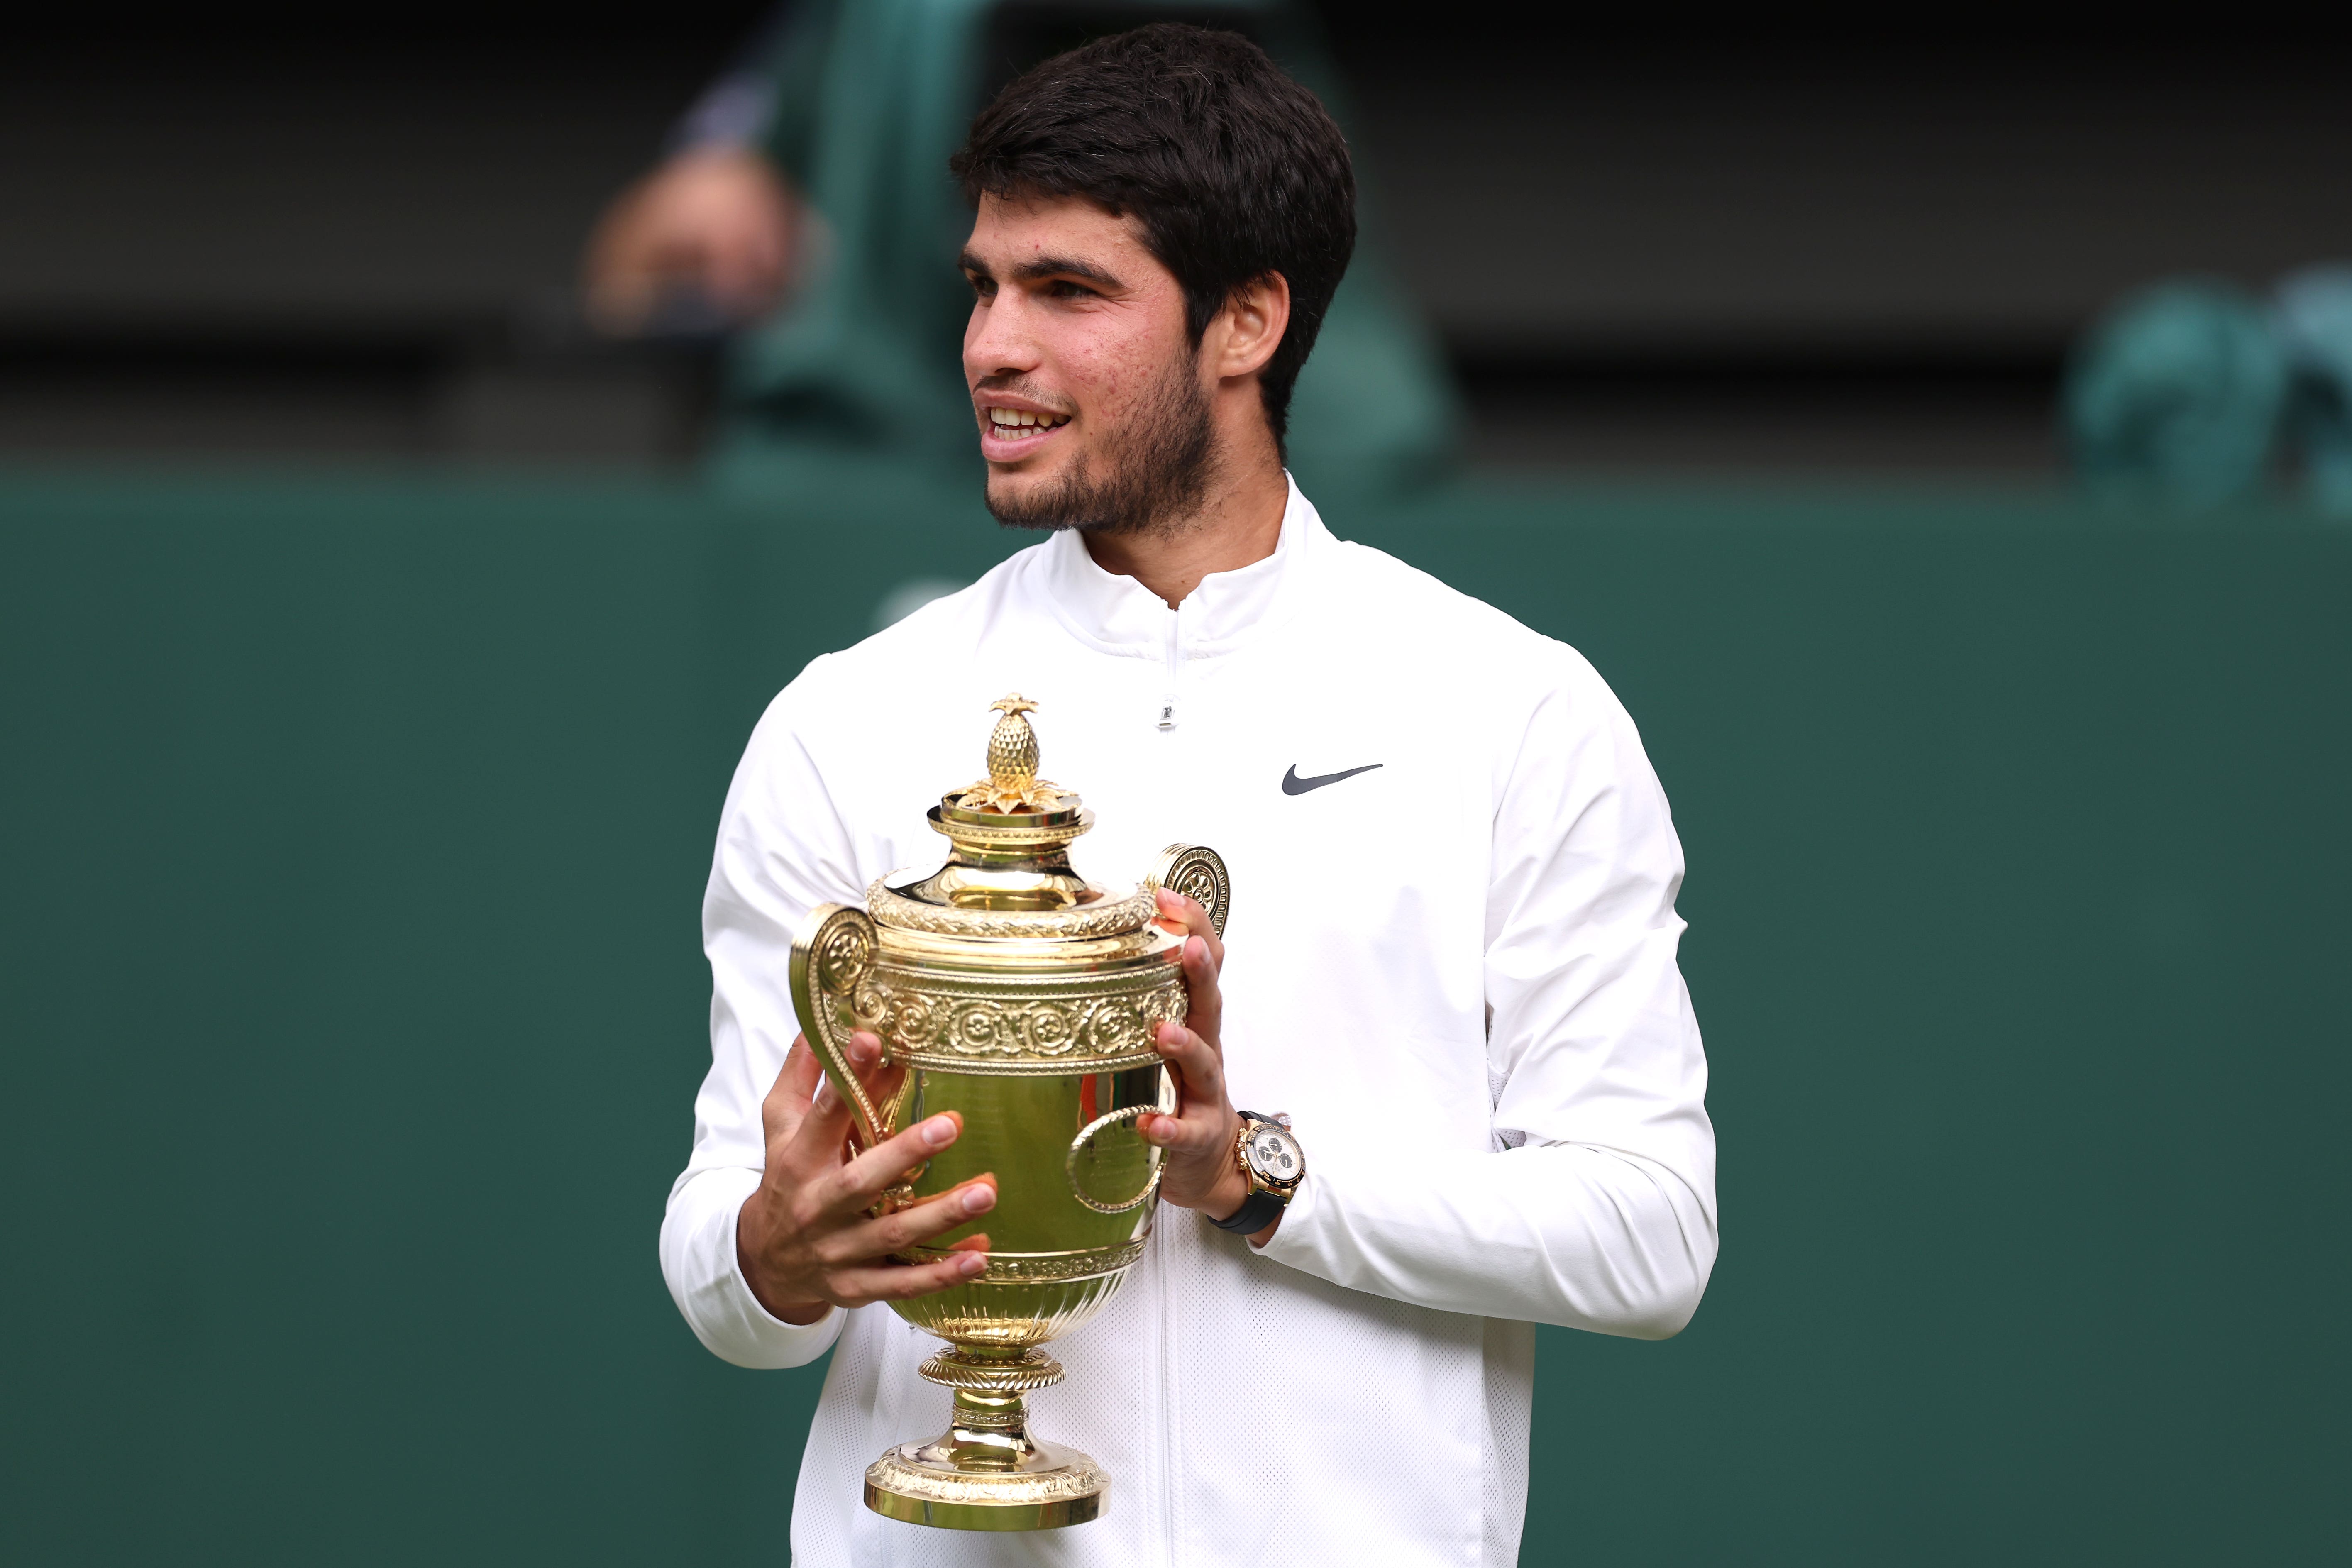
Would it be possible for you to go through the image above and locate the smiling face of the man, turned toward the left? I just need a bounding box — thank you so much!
[962,195,1216,531]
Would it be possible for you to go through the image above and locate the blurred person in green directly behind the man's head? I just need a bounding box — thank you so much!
[583,0,1458,498]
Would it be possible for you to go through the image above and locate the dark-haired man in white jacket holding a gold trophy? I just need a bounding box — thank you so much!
[661,26,1715,1568]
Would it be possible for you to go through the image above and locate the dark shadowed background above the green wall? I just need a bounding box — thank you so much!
[14,0,2352,479]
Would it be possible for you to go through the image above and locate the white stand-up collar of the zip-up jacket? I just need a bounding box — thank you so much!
[1042,475,1331,658]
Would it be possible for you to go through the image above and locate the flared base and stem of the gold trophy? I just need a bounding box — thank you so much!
[865,1345,1110,1530]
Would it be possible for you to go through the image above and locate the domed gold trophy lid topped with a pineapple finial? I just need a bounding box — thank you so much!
[896,691,1112,910]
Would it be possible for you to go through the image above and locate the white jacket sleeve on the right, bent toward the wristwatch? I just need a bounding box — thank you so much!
[1265,644,1717,1340]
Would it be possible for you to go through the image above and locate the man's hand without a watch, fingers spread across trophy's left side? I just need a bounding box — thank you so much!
[736,1032,997,1324]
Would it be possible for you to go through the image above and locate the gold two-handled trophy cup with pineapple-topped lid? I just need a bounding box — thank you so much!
[793,694,1230,1530]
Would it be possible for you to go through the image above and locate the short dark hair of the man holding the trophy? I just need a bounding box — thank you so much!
[948,21,1355,445]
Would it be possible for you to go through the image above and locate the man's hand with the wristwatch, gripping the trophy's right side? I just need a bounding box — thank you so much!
[1136,889,1282,1246]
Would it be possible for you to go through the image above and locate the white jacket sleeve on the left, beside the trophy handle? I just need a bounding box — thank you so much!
[661,661,858,1368]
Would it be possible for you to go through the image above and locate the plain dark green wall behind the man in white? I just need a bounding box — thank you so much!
[0,468,2352,1563]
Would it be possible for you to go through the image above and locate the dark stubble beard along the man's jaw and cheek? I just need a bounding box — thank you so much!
[985,355,1216,534]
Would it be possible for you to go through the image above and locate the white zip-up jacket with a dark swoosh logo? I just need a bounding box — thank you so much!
[661,486,1715,1568]
